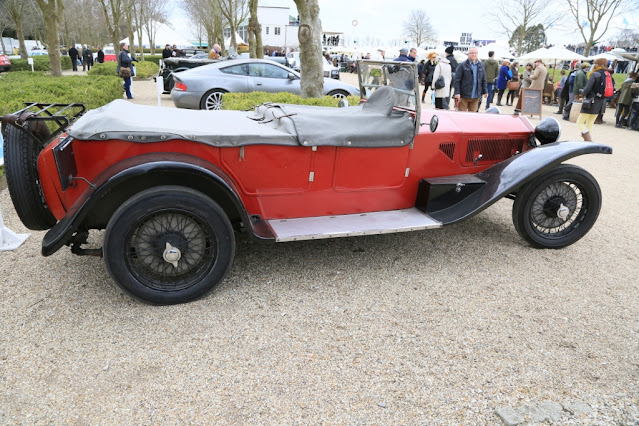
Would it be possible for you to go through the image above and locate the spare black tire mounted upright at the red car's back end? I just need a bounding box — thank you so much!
[4,121,57,231]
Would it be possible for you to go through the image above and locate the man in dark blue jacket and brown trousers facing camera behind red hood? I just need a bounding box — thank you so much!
[455,47,488,112]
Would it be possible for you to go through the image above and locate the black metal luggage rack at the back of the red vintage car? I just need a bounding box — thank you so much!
[2,102,86,145]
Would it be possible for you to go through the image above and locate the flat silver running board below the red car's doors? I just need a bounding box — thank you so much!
[266,208,442,243]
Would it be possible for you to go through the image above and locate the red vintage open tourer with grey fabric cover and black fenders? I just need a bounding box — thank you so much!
[3,61,612,304]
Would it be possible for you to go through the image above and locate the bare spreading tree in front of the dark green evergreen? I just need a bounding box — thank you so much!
[489,0,563,56]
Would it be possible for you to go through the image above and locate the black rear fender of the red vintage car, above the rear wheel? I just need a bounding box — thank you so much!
[42,153,272,256]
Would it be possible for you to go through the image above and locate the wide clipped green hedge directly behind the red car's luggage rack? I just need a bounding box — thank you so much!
[0,71,122,117]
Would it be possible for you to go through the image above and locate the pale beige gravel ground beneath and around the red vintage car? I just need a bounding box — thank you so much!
[0,72,639,425]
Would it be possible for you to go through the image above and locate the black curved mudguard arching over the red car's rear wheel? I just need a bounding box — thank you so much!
[42,154,264,256]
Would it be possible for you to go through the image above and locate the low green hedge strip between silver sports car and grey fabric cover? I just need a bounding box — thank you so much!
[223,92,360,110]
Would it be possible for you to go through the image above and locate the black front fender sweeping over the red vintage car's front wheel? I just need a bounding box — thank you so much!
[429,141,612,225]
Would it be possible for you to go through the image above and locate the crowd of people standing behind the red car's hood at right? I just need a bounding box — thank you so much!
[395,46,639,141]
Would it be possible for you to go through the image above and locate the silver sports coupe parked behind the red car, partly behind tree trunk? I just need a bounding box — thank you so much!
[171,59,359,109]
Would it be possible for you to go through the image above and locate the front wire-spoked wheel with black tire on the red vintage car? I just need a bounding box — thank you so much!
[513,164,601,249]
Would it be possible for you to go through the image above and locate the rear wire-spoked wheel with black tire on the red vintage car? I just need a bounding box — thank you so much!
[104,186,235,305]
